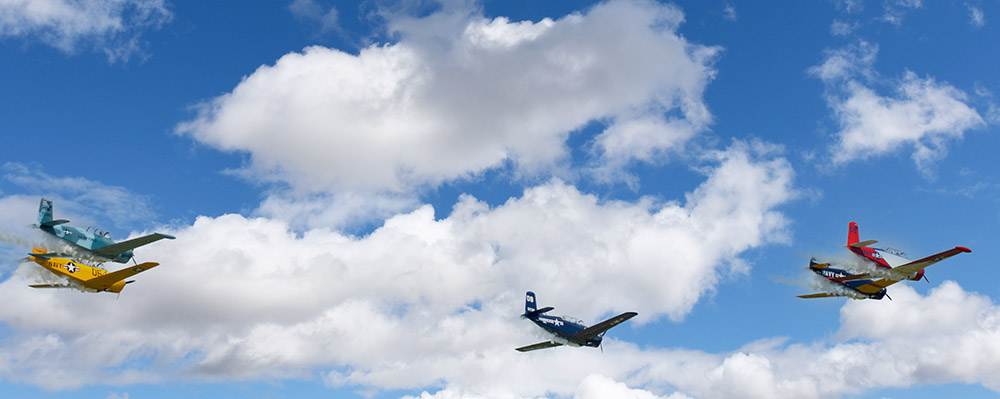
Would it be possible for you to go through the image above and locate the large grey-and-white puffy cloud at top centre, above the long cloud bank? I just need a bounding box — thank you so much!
[177,0,717,192]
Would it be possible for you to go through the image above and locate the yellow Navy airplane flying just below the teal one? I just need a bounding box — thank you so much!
[29,248,159,294]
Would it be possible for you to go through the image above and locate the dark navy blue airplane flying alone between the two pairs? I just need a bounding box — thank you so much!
[517,291,638,352]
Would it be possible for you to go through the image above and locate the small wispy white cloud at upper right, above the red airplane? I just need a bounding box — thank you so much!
[810,42,986,176]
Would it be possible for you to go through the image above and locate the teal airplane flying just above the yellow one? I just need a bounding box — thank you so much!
[34,198,174,263]
